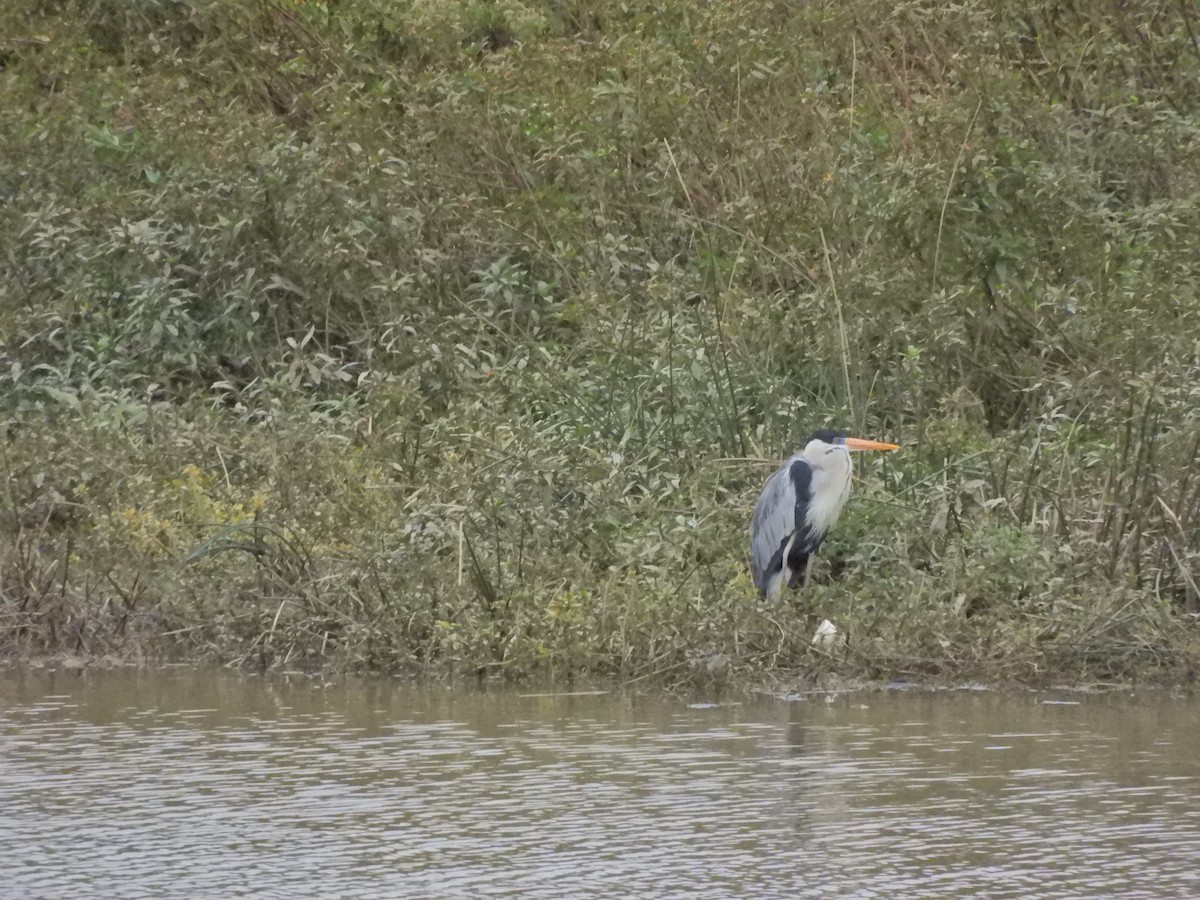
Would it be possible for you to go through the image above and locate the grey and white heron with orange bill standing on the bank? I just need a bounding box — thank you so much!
[750,428,900,599]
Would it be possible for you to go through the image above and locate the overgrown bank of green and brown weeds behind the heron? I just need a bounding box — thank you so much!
[0,0,1200,679]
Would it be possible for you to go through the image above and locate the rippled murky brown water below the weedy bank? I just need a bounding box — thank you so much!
[0,671,1200,898]
